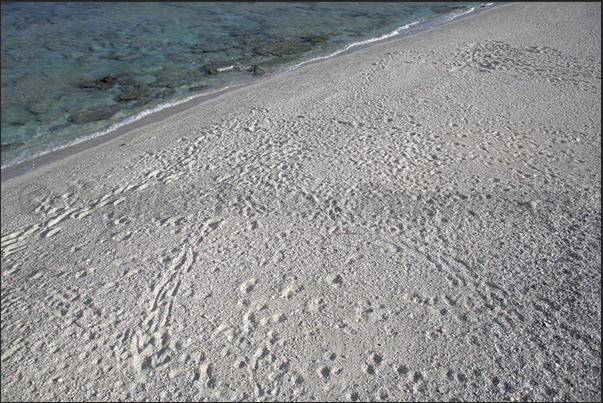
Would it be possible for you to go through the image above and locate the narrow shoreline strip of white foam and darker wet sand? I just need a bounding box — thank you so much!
[0,2,500,183]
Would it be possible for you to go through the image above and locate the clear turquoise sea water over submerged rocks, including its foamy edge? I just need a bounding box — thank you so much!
[1,2,492,169]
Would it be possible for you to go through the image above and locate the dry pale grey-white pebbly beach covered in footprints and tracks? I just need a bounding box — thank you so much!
[1,3,601,401]
